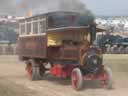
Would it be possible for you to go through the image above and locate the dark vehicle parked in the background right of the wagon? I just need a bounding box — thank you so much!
[97,35,128,54]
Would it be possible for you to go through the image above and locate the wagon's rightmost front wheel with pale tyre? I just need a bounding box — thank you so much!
[104,67,112,89]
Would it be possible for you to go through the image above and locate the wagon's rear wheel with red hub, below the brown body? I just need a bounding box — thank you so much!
[26,60,45,80]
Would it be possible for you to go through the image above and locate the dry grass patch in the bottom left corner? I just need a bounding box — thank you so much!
[0,78,34,96]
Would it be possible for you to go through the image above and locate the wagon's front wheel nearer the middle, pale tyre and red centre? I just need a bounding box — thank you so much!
[71,68,83,90]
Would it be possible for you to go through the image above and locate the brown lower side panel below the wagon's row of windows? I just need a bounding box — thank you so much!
[18,36,47,58]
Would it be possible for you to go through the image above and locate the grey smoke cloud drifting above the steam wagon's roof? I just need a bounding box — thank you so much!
[0,0,93,16]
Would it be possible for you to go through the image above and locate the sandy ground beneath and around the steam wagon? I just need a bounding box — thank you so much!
[0,55,128,96]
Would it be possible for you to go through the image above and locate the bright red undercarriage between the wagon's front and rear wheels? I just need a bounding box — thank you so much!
[50,64,74,78]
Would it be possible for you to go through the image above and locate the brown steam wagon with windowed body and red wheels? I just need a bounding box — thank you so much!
[17,11,112,90]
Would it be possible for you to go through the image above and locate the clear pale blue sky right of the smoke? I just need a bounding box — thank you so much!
[81,0,128,16]
